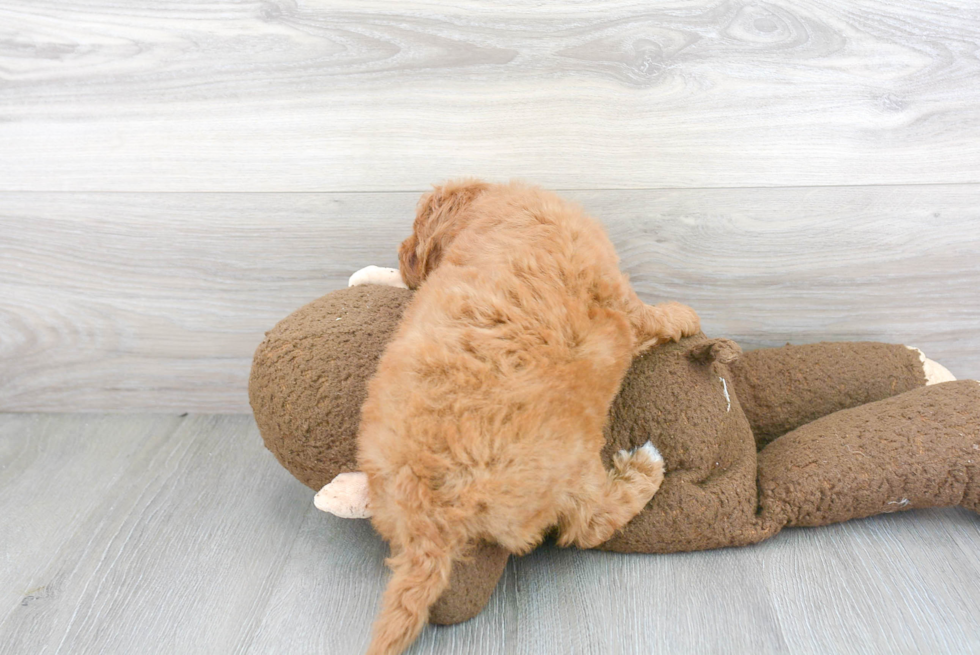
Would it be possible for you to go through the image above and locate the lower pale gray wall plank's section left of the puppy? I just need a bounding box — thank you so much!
[0,194,414,411]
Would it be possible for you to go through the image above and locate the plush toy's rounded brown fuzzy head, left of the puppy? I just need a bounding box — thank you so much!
[248,286,412,491]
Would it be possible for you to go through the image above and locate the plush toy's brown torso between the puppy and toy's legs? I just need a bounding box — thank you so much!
[602,335,756,553]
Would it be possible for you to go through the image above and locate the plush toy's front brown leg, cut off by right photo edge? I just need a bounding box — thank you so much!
[758,380,980,529]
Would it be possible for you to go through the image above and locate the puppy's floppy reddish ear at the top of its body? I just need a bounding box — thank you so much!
[398,178,490,289]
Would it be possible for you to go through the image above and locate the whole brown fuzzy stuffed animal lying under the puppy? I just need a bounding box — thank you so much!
[249,280,980,624]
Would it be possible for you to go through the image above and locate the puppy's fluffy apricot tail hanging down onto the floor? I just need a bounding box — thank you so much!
[367,482,456,655]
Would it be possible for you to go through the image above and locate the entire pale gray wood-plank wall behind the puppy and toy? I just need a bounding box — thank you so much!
[0,0,980,412]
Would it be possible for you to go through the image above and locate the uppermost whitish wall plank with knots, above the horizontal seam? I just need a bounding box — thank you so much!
[0,0,980,191]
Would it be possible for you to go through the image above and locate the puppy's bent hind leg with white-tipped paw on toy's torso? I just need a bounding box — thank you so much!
[558,441,664,548]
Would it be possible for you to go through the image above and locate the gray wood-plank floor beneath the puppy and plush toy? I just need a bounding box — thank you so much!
[0,415,980,655]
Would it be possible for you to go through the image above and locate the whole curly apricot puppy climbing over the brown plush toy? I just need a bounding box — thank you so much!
[358,180,699,654]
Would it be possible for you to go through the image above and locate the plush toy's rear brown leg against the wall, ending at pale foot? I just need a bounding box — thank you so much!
[730,342,936,449]
